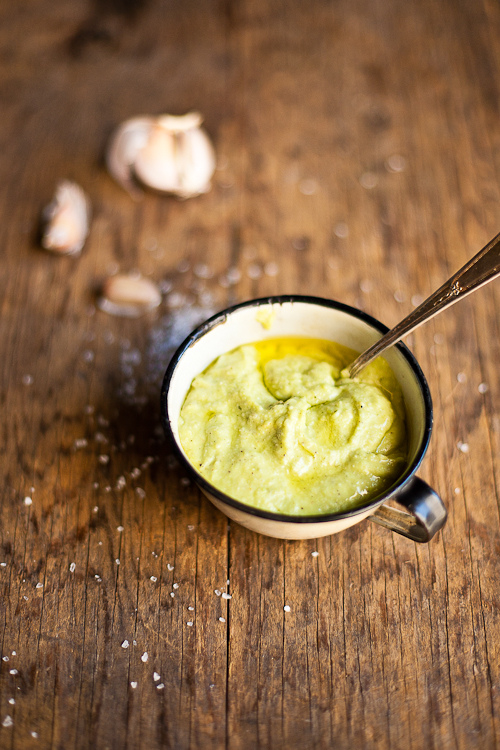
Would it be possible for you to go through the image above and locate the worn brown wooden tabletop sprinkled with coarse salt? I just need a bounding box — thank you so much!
[0,0,500,750]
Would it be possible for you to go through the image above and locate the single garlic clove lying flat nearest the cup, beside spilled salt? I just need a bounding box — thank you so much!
[98,274,161,318]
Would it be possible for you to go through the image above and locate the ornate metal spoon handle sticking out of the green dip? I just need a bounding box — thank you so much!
[348,234,500,378]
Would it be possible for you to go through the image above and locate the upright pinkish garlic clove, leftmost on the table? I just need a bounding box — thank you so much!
[42,180,90,255]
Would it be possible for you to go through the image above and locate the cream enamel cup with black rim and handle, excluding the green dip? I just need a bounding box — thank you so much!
[161,295,446,542]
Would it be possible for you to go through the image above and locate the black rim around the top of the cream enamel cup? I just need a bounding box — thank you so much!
[160,294,433,524]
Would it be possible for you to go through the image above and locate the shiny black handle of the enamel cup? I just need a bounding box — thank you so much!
[370,477,448,542]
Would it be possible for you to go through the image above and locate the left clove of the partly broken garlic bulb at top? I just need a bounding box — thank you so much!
[106,116,154,199]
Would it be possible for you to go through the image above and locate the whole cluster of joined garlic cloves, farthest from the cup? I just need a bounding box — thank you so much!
[107,112,215,198]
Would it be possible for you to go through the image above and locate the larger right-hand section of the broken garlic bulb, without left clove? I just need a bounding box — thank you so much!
[134,112,216,198]
